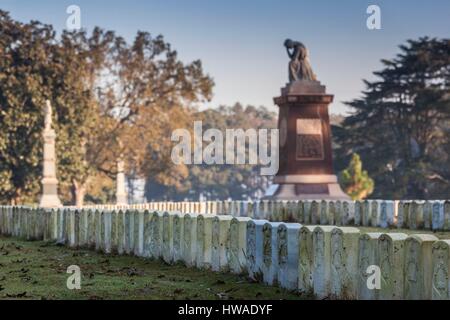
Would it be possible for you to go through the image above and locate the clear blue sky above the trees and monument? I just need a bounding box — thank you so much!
[0,0,450,113]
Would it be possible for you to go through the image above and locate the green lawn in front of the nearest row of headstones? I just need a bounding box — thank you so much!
[0,237,307,300]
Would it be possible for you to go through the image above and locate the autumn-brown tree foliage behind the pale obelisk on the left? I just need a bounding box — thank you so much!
[0,11,213,206]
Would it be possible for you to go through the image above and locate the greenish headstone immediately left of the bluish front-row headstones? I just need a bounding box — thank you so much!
[226,217,250,274]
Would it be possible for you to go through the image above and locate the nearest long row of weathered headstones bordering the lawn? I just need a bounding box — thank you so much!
[0,207,450,299]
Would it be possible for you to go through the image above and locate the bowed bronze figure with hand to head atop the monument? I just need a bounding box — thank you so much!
[284,39,317,82]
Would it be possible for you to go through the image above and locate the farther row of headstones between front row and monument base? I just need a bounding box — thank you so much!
[80,200,450,230]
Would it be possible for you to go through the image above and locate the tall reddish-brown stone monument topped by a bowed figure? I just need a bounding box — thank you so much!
[267,39,349,200]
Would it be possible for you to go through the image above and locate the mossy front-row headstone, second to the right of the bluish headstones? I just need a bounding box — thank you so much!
[313,226,334,299]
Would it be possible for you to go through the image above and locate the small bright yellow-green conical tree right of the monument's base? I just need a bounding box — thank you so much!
[339,153,374,200]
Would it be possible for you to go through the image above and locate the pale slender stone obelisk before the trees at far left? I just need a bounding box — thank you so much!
[39,100,61,208]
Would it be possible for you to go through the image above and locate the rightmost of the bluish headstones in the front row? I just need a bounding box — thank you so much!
[277,223,302,290]
